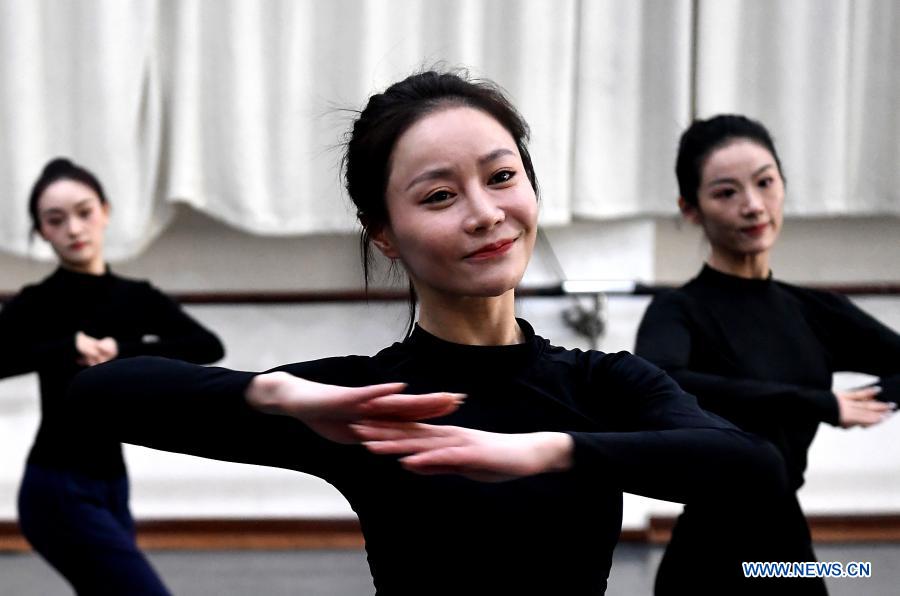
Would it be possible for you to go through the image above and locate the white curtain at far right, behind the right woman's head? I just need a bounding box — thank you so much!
[696,0,900,215]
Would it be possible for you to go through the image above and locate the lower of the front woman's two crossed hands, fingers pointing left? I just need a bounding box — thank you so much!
[353,420,574,482]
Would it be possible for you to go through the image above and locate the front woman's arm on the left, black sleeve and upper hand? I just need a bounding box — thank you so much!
[67,357,459,475]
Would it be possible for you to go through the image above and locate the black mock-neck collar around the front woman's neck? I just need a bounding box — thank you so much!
[403,319,541,367]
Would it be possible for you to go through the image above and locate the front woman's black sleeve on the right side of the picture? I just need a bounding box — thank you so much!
[570,353,787,503]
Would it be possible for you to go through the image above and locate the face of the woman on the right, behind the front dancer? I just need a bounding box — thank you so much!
[682,139,784,259]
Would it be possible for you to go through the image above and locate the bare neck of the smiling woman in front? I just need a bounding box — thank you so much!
[418,290,522,346]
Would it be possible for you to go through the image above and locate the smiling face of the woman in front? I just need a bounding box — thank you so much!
[373,107,537,299]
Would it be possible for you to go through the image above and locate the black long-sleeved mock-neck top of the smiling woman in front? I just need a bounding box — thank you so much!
[70,320,787,596]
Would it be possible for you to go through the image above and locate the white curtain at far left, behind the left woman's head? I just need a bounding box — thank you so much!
[0,0,168,258]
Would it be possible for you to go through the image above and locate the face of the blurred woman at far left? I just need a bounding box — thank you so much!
[38,179,109,272]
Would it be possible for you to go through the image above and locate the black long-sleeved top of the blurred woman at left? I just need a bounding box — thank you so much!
[0,268,224,477]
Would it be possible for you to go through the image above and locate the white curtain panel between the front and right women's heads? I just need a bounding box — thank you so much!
[572,0,691,218]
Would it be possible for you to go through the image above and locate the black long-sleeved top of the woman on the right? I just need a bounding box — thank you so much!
[635,265,900,488]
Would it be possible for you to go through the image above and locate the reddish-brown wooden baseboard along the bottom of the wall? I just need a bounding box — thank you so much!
[0,514,900,552]
